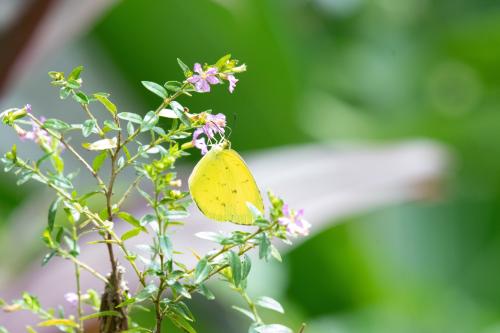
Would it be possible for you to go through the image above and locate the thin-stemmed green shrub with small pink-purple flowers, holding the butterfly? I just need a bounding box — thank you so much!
[0,55,310,333]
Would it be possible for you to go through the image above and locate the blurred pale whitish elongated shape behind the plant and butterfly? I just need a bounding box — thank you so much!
[0,141,448,332]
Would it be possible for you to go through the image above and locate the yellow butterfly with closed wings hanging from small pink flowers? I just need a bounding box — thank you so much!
[189,141,264,225]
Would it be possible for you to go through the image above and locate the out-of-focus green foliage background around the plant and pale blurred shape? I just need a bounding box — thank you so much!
[0,0,500,333]
